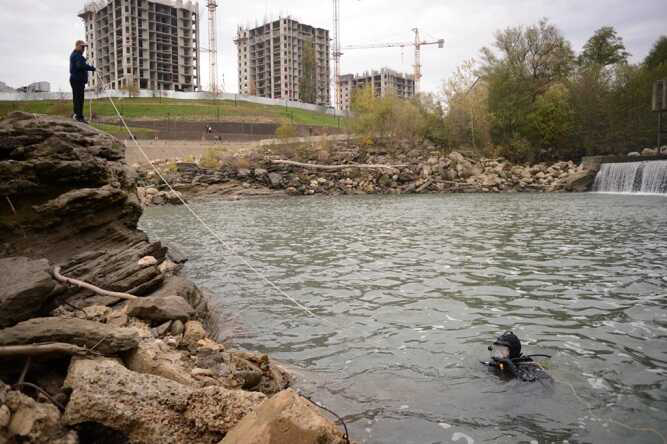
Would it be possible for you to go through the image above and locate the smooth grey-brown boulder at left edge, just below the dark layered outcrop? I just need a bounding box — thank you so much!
[0,257,56,328]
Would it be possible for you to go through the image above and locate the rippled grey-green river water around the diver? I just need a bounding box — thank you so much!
[142,194,667,444]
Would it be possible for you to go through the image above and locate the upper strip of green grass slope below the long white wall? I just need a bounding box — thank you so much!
[0,98,345,127]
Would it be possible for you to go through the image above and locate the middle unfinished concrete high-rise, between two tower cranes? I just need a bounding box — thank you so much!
[234,17,331,105]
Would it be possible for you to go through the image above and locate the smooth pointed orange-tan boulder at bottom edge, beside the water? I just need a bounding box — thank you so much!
[220,389,348,444]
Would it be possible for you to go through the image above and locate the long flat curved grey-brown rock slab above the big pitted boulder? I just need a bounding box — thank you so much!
[0,317,138,354]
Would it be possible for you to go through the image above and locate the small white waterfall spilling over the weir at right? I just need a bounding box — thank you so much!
[593,160,667,194]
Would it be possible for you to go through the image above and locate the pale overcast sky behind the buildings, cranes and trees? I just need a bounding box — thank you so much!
[0,0,667,92]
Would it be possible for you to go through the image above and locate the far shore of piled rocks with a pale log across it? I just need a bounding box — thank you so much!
[133,142,595,206]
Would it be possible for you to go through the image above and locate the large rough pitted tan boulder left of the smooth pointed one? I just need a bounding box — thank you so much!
[63,358,265,444]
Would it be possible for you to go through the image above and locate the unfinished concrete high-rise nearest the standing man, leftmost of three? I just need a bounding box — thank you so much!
[79,0,201,91]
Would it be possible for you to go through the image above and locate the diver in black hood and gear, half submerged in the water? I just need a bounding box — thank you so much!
[482,331,551,382]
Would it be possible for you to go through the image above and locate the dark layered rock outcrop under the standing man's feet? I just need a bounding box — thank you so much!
[0,112,141,245]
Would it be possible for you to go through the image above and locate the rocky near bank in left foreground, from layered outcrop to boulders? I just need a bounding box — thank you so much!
[0,113,347,444]
